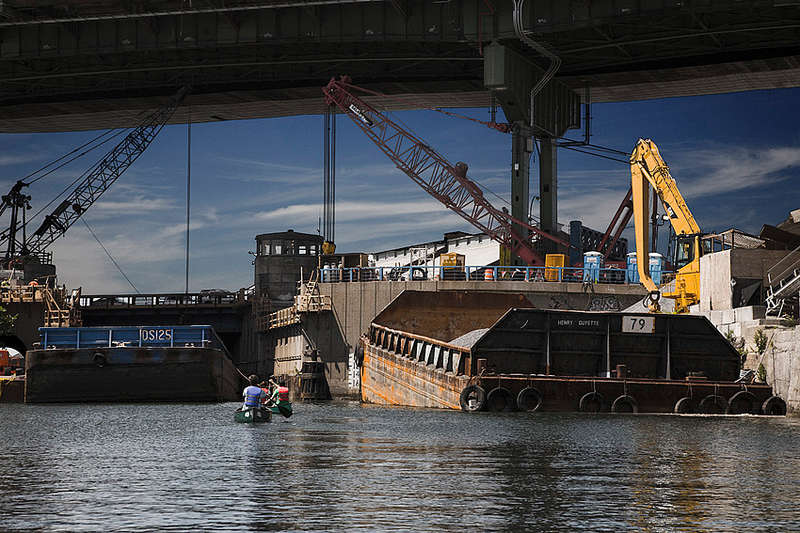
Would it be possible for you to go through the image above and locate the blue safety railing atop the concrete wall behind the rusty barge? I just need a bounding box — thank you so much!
[319,265,671,285]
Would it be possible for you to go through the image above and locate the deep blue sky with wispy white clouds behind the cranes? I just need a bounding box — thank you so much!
[0,89,800,294]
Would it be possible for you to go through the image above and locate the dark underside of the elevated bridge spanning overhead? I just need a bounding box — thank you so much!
[0,0,800,132]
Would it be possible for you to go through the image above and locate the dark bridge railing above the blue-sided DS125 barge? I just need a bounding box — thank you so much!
[79,291,250,309]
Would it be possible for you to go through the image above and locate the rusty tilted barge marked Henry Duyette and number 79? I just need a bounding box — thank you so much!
[360,291,786,415]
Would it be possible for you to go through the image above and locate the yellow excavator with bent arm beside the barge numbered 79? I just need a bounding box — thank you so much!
[631,139,703,313]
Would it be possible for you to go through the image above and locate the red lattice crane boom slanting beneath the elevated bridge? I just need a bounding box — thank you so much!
[322,77,569,266]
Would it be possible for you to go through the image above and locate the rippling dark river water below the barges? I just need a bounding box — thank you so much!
[0,403,800,531]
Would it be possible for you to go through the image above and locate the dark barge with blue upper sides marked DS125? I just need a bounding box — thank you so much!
[25,326,240,403]
